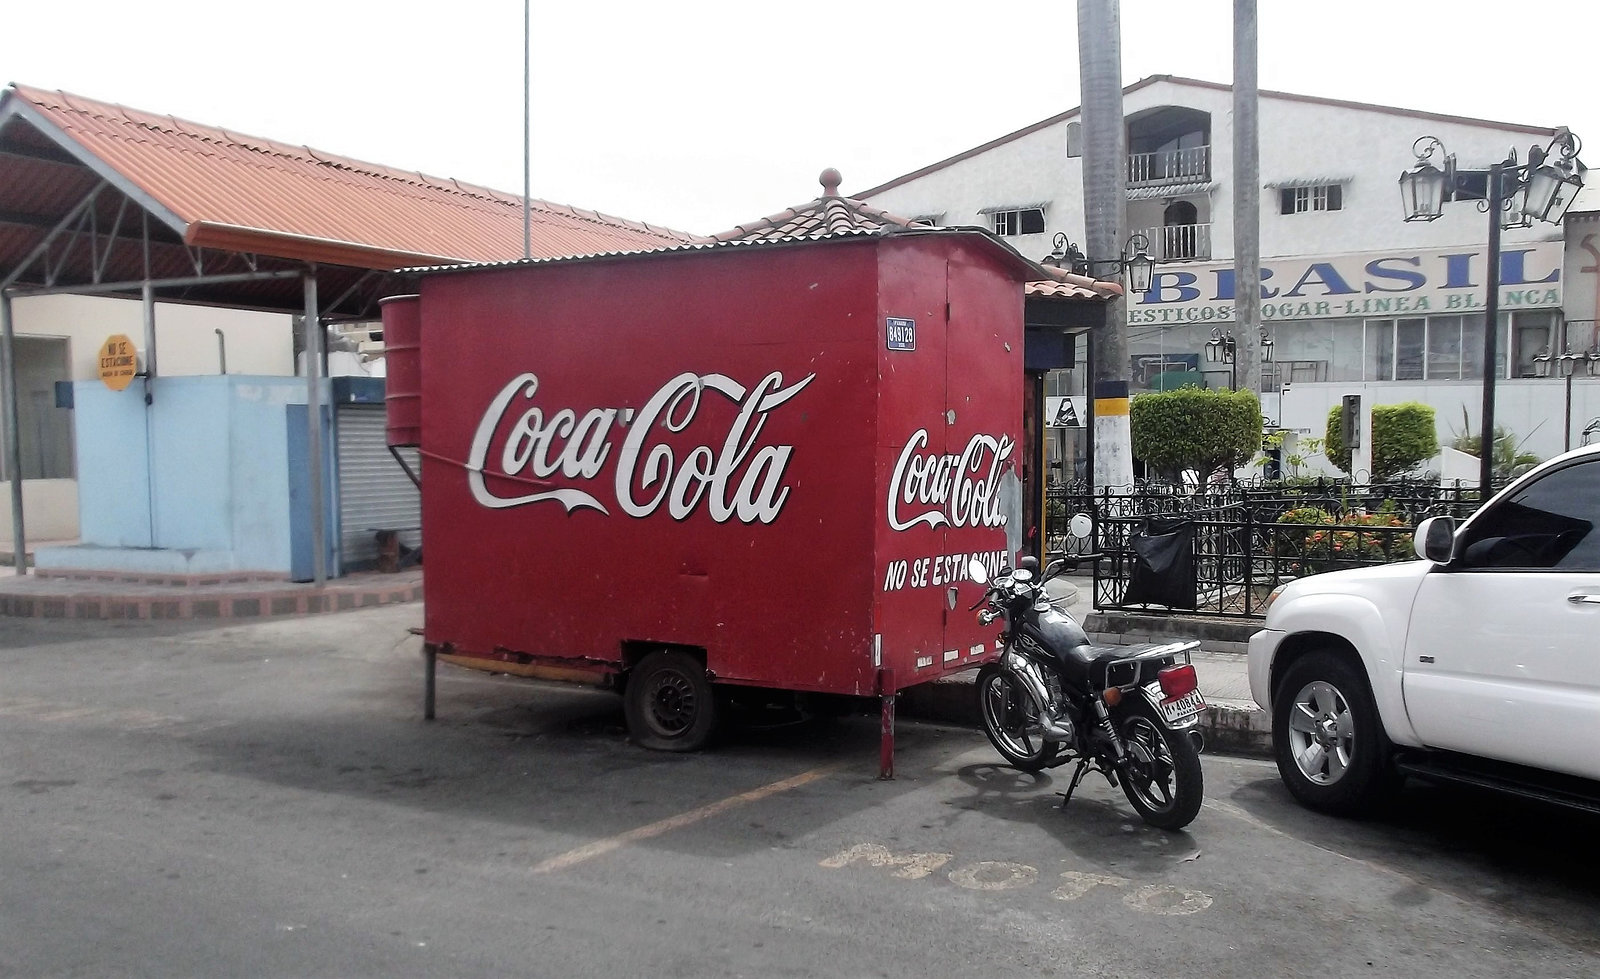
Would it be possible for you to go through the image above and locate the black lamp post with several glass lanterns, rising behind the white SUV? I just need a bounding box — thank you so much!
[1400,128,1584,499]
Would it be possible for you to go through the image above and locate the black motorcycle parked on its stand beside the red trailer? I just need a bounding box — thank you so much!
[968,555,1205,830]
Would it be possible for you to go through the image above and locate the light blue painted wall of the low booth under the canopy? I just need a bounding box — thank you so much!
[74,374,333,574]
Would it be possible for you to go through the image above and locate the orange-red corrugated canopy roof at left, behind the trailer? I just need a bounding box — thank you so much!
[0,85,701,269]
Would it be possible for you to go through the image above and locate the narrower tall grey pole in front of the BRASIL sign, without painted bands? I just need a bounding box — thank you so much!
[1234,0,1254,398]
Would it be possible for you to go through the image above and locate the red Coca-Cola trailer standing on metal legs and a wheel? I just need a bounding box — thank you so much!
[384,229,1038,769]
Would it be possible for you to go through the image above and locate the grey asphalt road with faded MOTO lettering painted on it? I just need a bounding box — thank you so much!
[0,606,1600,979]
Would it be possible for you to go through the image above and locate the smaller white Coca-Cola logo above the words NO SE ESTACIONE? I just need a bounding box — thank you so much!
[888,429,1016,531]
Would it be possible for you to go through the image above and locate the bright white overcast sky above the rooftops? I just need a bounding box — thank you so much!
[0,0,1600,234]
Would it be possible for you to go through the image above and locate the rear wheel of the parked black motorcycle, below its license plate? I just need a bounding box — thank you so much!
[1118,697,1205,830]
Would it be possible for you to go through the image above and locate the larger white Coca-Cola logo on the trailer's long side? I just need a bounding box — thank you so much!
[467,371,816,523]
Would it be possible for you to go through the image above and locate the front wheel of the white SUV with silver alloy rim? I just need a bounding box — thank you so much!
[1272,649,1392,816]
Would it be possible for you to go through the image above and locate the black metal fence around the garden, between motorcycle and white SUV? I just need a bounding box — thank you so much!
[1046,480,1480,617]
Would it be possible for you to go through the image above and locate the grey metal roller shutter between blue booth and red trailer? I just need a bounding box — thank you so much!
[338,405,422,574]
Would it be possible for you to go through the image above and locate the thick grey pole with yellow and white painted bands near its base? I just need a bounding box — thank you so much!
[1078,0,1133,490]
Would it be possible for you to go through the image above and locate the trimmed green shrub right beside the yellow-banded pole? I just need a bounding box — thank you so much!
[1128,387,1261,480]
